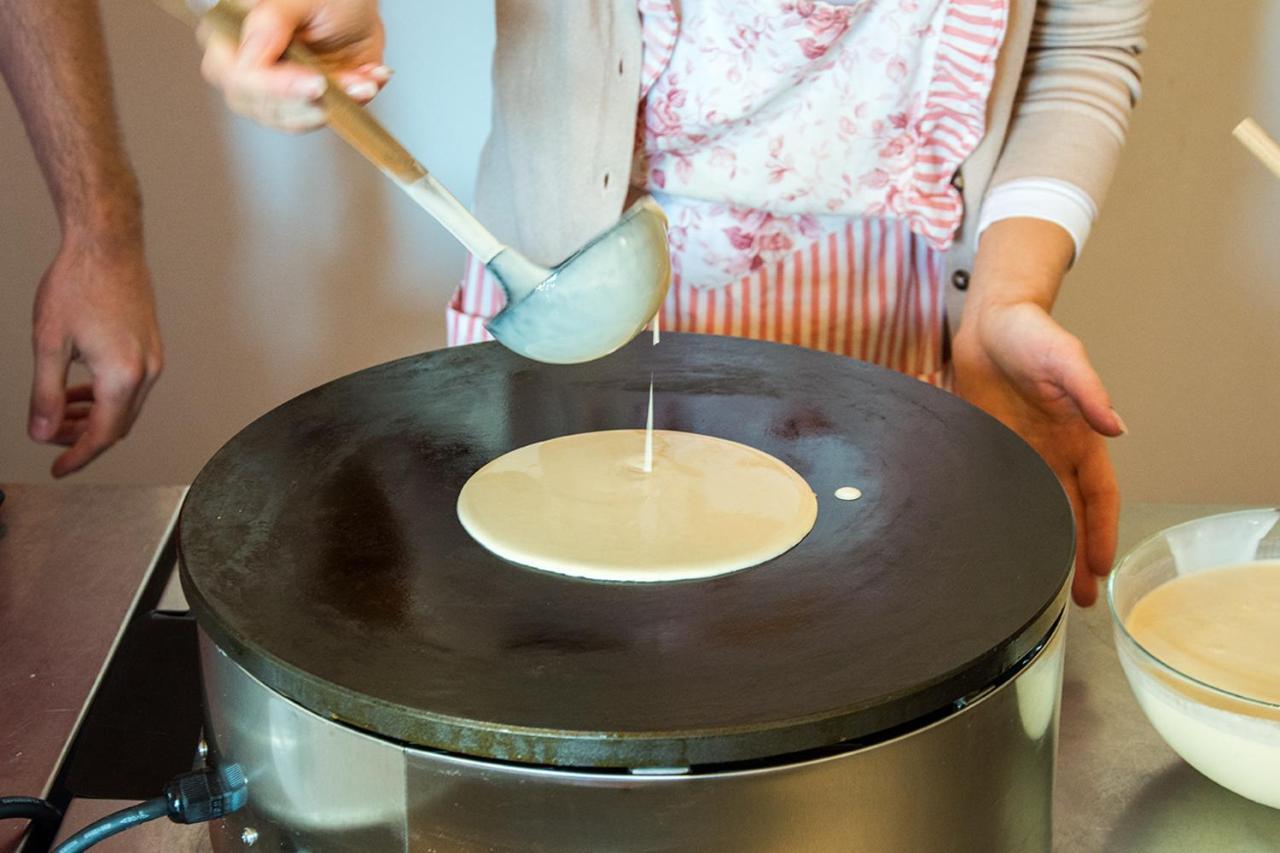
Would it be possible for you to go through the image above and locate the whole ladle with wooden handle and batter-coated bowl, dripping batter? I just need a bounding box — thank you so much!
[156,0,671,364]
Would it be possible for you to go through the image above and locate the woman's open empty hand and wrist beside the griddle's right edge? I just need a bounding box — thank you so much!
[952,219,1125,606]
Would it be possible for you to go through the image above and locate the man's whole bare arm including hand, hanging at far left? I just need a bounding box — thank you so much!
[0,0,161,476]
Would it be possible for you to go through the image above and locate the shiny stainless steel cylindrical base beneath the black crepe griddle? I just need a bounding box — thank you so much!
[201,610,1065,853]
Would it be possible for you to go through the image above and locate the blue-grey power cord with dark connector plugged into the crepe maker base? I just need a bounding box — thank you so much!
[54,765,248,853]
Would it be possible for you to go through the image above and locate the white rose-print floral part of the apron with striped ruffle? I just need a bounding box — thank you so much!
[632,0,1007,287]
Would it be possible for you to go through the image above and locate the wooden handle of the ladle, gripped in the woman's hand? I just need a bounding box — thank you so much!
[192,0,428,184]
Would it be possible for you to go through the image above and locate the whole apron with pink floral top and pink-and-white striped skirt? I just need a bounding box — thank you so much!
[447,0,1006,384]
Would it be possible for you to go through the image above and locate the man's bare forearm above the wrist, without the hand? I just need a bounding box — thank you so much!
[0,0,142,241]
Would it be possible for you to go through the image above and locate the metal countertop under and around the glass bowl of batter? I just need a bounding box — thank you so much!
[1053,503,1280,853]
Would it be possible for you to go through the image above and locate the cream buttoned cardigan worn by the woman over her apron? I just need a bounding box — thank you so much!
[476,0,1149,328]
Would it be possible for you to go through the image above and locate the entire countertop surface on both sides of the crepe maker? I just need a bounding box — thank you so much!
[0,485,1280,853]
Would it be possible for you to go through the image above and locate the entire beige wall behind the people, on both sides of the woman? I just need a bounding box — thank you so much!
[0,0,1280,501]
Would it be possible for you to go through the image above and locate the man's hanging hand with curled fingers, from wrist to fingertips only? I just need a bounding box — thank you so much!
[28,232,161,476]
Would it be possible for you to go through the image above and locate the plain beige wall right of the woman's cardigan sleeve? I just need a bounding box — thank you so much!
[1057,0,1280,502]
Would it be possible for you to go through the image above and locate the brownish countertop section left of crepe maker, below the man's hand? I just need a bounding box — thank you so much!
[0,485,186,852]
